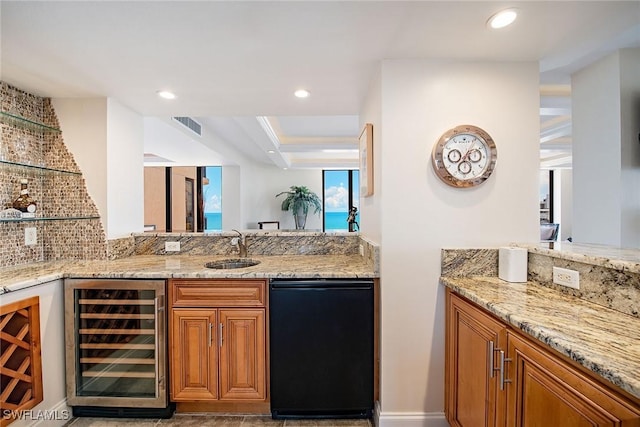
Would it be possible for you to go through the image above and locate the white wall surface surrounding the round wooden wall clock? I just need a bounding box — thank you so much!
[362,60,539,427]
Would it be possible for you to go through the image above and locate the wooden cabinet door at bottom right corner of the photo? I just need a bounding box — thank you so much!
[507,332,640,427]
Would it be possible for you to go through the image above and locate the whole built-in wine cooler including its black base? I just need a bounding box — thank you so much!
[65,279,173,417]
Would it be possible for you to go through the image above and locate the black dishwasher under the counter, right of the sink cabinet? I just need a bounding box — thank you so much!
[269,279,374,418]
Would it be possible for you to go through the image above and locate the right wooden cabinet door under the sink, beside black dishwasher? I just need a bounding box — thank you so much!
[219,309,266,400]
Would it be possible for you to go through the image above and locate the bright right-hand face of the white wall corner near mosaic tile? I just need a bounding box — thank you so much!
[106,98,144,239]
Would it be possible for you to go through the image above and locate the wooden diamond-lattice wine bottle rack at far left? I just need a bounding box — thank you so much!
[0,296,43,426]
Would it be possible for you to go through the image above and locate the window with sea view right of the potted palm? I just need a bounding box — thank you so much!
[322,170,360,231]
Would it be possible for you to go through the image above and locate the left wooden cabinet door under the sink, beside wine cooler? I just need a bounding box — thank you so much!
[169,308,218,401]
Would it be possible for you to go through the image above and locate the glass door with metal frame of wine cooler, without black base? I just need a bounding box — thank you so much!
[66,281,166,406]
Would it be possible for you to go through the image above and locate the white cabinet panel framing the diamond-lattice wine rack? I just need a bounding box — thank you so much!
[0,280,71,427]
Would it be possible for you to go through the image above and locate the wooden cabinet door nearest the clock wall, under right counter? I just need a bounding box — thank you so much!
[445,290,506,427]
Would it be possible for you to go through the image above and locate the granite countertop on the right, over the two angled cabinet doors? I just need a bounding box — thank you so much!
[440,276,640,399]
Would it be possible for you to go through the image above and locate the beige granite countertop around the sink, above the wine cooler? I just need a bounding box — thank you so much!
[0,255,378,294]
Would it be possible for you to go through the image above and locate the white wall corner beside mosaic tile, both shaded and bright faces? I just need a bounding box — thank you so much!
[52,98,144,239]
